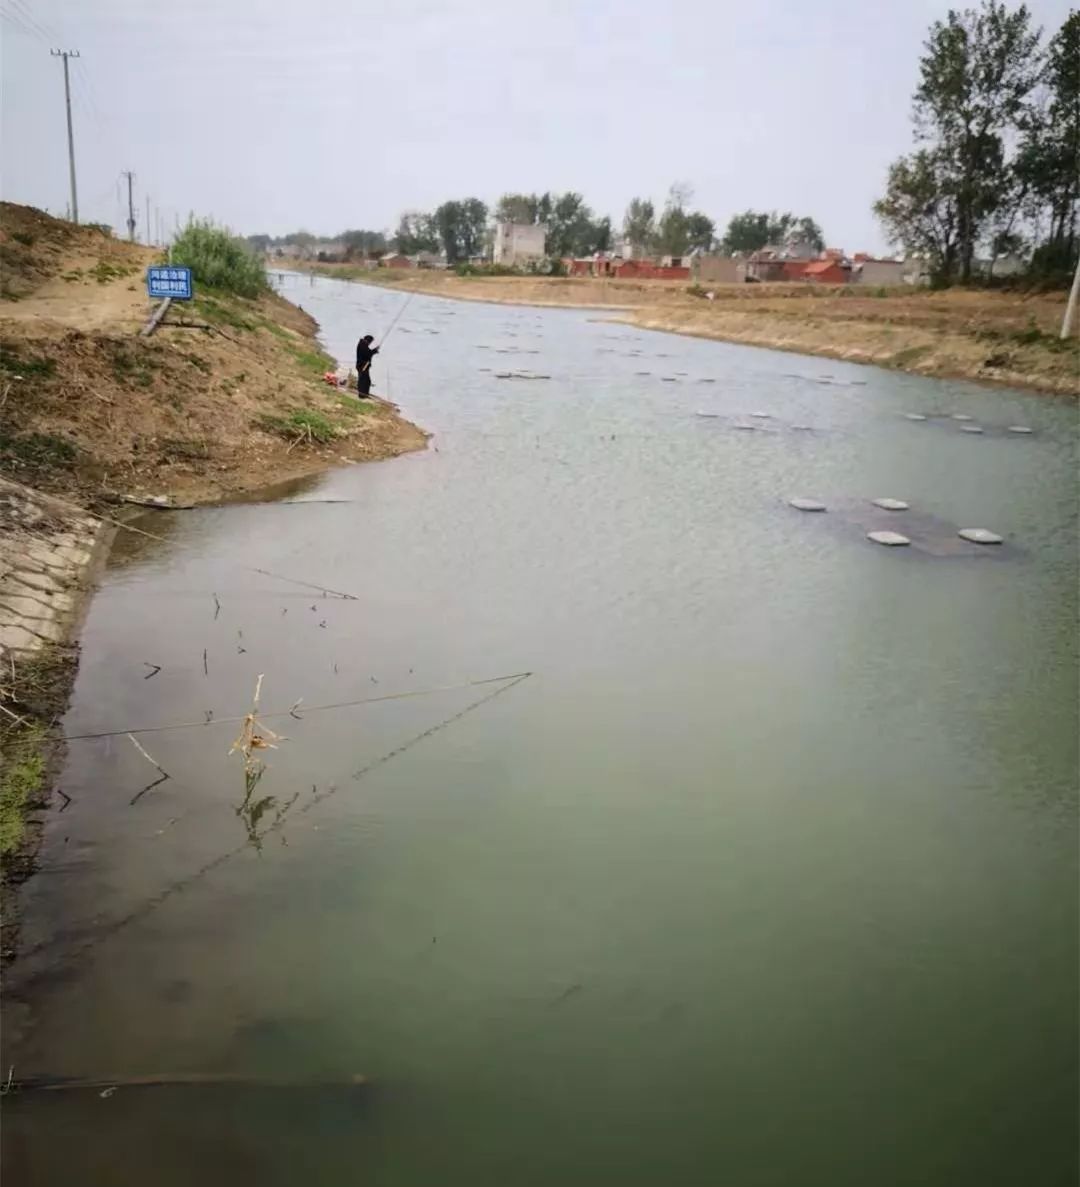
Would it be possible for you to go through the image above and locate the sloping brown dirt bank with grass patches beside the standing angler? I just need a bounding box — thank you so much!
[0,203,426,502]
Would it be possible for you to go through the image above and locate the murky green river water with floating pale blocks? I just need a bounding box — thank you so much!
[5,277,1078,1187]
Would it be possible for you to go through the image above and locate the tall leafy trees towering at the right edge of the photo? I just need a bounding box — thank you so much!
[873,0,1080,284]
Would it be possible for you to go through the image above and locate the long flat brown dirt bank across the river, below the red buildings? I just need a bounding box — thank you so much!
[289,264,1080,395]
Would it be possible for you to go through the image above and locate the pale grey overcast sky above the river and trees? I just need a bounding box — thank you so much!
[0,0,1069,250]
